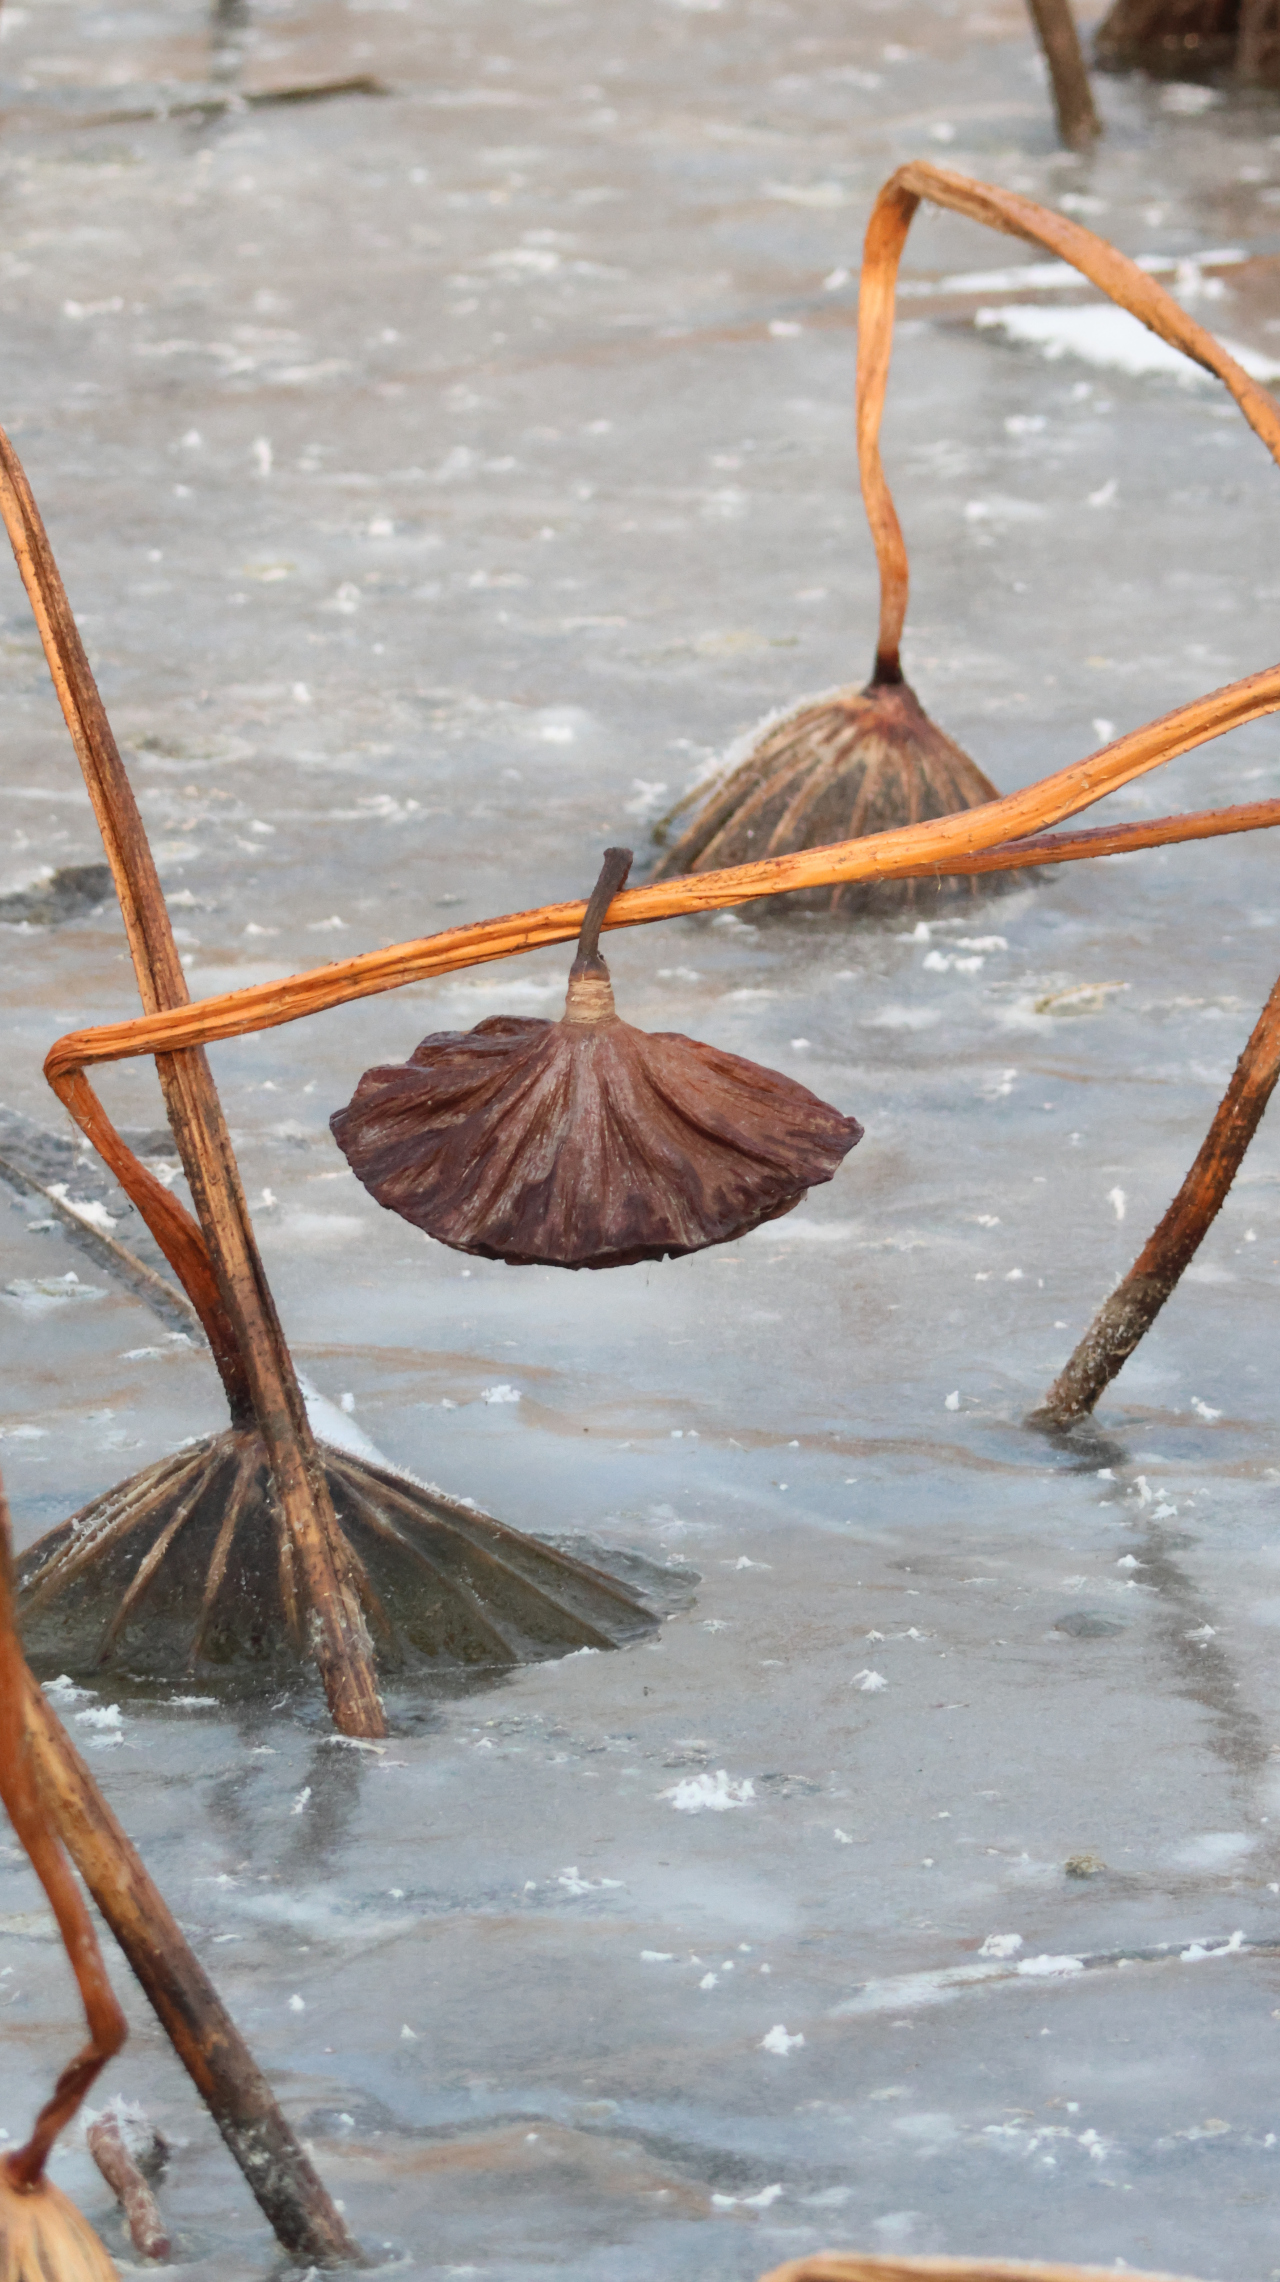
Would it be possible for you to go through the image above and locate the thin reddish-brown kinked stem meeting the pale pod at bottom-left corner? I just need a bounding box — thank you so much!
[0,1488,128,2191]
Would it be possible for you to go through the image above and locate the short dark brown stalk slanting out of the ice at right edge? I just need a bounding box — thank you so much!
[1029,963,1280,1429]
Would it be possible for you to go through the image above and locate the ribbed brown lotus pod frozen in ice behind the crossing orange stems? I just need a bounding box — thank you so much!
[653,680,1004,915]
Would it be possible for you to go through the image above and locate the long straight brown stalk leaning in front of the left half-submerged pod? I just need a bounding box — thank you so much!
[0,431,386,1737]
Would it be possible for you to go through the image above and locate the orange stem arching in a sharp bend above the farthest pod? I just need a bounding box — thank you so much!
[858,160,1280,682]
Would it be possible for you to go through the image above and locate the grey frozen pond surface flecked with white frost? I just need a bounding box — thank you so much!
[0,0,1280,2282]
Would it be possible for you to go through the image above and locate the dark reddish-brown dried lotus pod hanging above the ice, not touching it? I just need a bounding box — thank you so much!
[329,849,862,1269]
